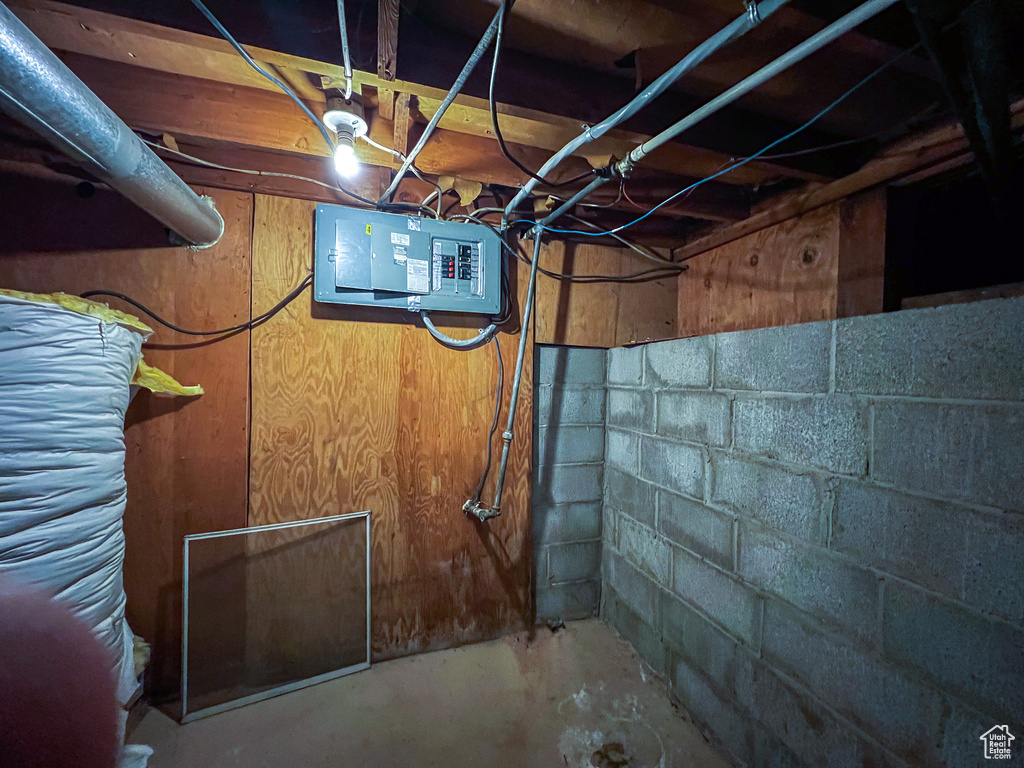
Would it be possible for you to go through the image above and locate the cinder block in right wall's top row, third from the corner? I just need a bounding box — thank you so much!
[715,323,831,393]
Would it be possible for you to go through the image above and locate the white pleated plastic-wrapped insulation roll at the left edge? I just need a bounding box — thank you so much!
[0,295,144,703]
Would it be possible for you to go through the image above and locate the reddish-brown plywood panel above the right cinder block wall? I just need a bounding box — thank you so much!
[677,189,886,337]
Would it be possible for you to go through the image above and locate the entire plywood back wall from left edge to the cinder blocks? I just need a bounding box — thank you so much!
[0,175,532,695]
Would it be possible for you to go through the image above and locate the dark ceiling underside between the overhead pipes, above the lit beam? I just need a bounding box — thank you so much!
[64,0,942,177]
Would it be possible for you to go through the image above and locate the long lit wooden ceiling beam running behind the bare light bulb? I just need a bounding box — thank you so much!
[4,0,811,185]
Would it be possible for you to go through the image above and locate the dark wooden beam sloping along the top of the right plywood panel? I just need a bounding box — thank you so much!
[676,99,1024,258]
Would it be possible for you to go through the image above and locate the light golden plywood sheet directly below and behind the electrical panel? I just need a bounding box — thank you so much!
[250,196,532,659]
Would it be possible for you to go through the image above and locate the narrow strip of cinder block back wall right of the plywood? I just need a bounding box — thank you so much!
[531,345,605,622]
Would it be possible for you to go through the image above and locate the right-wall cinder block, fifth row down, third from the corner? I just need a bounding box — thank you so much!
[672,549,761,648]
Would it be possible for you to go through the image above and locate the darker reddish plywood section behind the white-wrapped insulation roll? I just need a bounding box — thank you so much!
[0,176,253,693]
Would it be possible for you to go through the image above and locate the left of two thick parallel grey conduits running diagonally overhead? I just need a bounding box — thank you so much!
[505,0,788,218]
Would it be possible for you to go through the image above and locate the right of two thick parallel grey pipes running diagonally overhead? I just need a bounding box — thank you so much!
[615,0,899,173]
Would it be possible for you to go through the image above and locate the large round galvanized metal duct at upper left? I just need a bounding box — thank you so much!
[0,4,224,248]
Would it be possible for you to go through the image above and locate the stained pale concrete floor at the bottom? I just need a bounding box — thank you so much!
[131,621,729,768]
